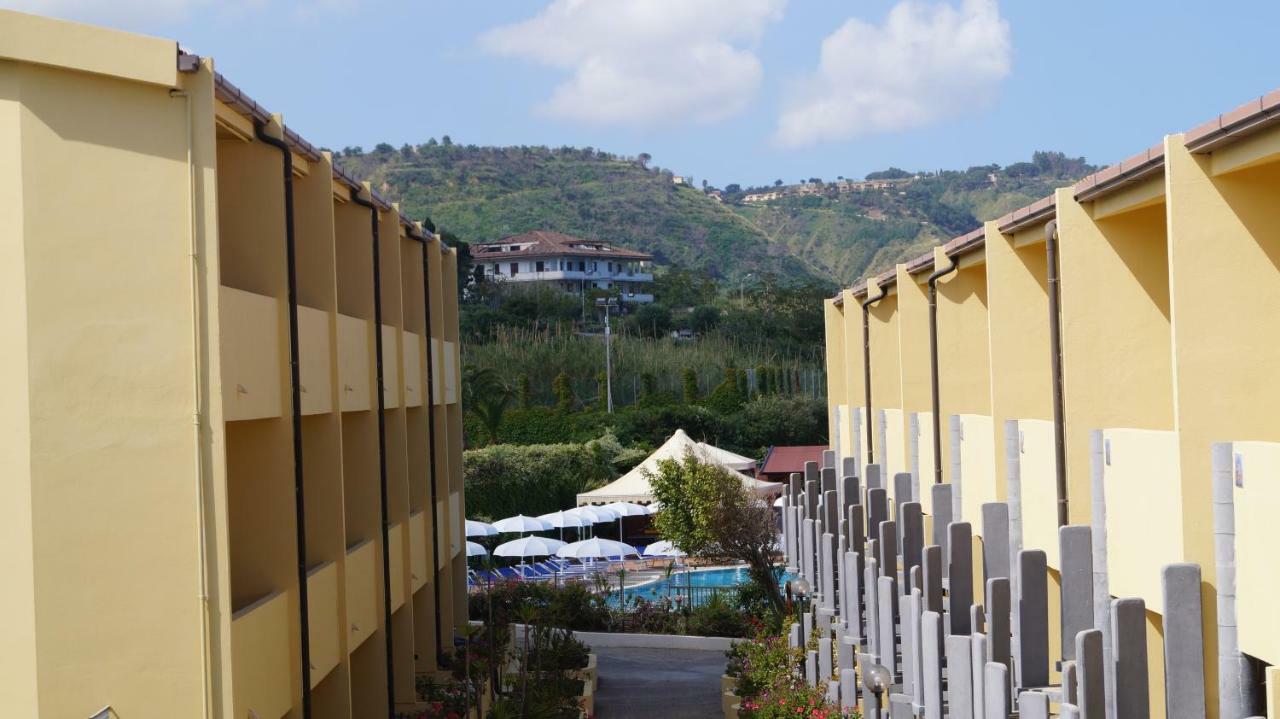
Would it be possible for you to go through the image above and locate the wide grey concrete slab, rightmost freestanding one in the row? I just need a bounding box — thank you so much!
[1162,564,1204,719]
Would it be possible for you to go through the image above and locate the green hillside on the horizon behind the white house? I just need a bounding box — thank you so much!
[338,138,1094,283]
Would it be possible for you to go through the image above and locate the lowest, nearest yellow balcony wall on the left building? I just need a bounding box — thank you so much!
[232,592,293,719]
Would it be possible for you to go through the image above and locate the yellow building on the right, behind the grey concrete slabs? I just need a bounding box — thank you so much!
[826,91,1280,716]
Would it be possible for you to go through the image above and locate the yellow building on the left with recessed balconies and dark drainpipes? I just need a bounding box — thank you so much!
[0,10,466,719]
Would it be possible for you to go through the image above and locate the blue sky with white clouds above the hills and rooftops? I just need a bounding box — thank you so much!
[10,0,1280,187]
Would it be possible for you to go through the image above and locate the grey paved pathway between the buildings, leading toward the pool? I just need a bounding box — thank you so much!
[593,647,724,719]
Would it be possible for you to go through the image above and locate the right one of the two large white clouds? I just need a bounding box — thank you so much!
[774,0,1012,147]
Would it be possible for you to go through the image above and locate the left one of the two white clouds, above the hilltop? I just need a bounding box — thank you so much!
[480,0,786,125]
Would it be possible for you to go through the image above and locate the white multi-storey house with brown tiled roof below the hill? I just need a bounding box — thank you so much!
[471,230,653,302]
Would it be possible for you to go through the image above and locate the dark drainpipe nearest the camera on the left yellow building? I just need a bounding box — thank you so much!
[253,123,311,719]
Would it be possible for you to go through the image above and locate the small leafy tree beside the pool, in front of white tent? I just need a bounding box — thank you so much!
[645,453,785,617]
